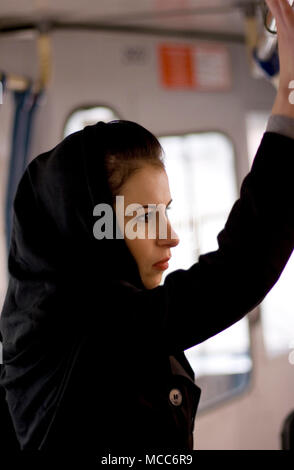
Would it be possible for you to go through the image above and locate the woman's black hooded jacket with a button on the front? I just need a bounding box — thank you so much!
[0,122,294,452]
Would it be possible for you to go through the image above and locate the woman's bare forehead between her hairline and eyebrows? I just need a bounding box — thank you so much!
[121,165,171,205]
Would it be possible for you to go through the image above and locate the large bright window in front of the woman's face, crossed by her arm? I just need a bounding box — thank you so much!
[159,132,252,410]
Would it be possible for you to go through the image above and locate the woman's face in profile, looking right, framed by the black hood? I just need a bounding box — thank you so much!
[116,164,179,289]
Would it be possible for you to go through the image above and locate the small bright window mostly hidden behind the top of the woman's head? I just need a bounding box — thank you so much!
[63,106,119,137]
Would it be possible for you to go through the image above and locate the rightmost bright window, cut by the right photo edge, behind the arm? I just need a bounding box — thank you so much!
[246,111,294,364]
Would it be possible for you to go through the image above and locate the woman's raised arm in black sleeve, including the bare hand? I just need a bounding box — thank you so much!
[122,0,294,353]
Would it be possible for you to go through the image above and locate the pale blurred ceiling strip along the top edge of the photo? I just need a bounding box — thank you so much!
[0,0,262,34]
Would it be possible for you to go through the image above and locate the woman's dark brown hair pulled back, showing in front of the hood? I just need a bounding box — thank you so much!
[105,120,165,200]
